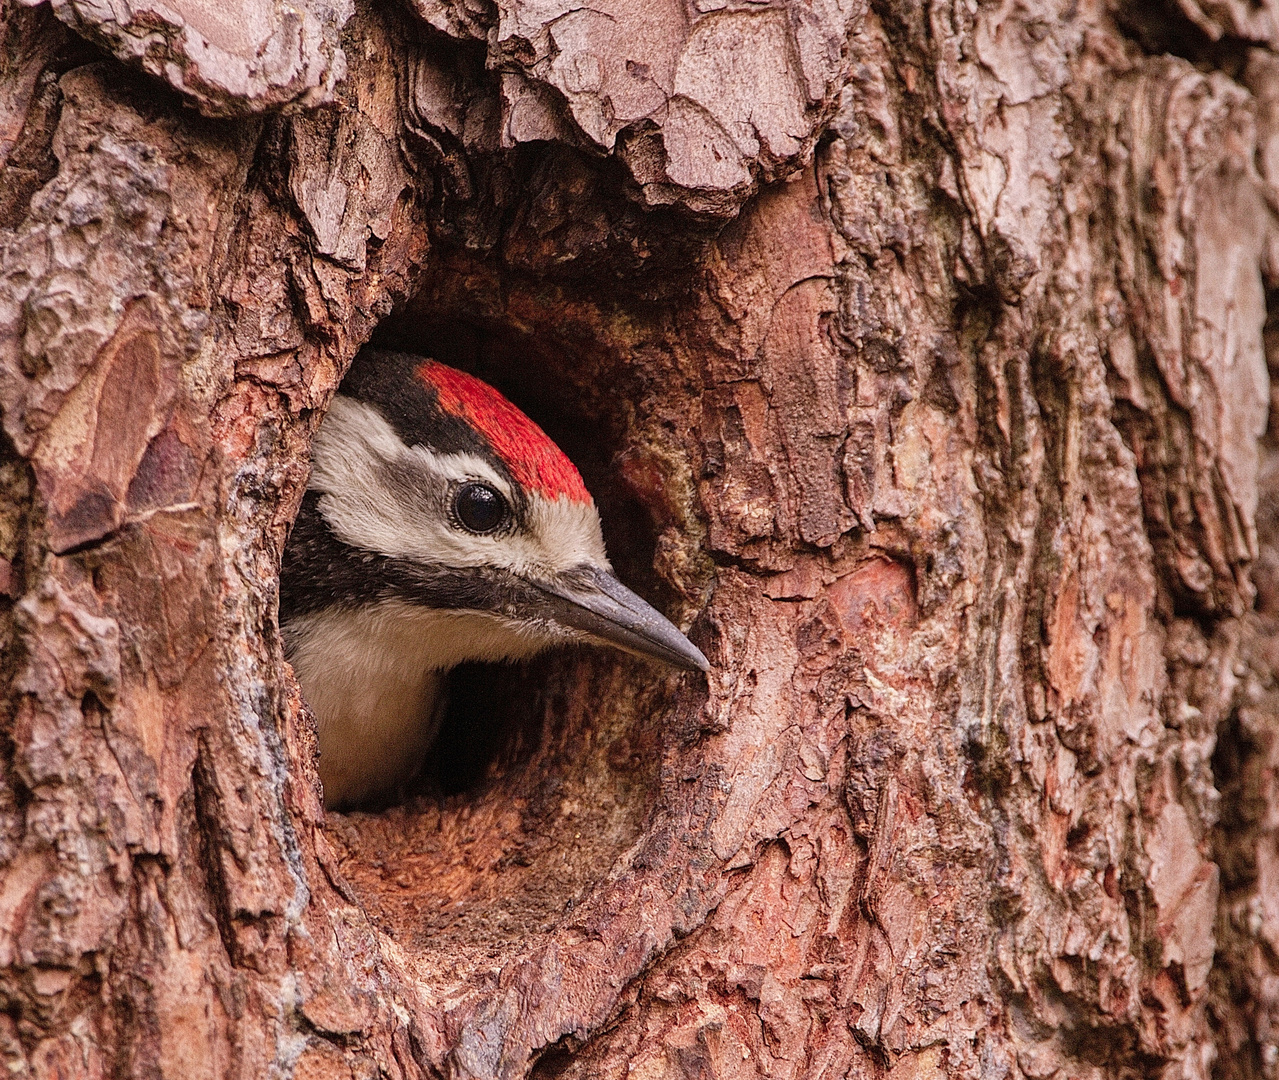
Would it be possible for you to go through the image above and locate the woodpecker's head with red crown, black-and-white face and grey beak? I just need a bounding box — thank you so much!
[280,352,709,690]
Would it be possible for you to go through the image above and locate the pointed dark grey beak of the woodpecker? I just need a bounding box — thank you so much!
[536,566,711,672]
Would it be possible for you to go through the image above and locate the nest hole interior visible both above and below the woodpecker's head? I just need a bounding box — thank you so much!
[303,312,695,967]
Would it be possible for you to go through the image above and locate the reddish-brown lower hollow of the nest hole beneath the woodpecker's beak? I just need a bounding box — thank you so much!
[319,649,670,957]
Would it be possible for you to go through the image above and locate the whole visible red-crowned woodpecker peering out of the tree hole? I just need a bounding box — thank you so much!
[280,349,710,809]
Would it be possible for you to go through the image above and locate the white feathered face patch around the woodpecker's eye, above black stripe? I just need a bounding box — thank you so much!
[311,394,609,578]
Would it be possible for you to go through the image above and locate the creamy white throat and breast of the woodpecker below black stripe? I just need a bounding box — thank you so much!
[290,600,564,809]
